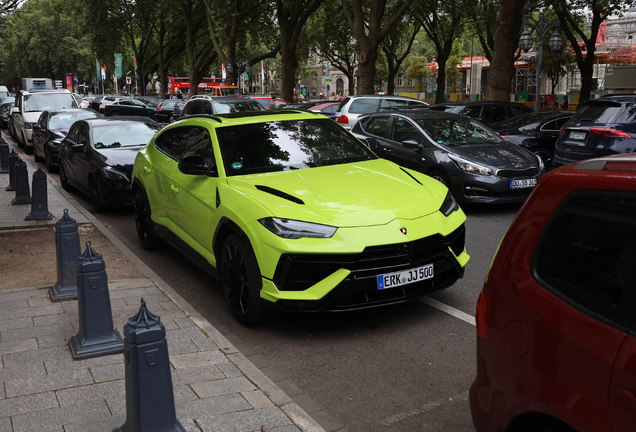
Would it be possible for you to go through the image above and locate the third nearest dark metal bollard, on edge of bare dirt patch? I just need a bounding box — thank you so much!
[49,209,82,301]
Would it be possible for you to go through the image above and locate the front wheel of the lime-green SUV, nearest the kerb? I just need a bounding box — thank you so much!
[218,233,267,326]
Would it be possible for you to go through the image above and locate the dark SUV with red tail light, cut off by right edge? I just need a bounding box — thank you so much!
[554,95,636,166]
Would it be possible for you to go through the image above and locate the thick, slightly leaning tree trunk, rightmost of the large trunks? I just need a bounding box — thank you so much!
[484,0,526,101]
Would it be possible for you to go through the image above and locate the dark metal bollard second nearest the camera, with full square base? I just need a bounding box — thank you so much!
[68,242,124,360]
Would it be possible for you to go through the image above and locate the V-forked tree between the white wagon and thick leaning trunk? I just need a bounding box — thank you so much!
[416,0,466,103]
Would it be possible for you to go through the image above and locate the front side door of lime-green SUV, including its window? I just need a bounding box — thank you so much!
[167,126,218,255]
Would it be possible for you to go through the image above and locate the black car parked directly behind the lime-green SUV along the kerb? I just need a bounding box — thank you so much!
[59,117,161,211]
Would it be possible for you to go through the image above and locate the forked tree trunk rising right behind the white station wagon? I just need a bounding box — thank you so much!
[342,0,413,94]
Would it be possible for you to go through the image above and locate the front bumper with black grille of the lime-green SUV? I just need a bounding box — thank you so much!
[261,225,469,312]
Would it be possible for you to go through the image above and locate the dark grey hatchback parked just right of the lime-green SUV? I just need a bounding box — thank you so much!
[351,110,545,203]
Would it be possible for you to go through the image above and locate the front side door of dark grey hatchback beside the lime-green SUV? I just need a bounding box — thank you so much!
[388,115,431,172]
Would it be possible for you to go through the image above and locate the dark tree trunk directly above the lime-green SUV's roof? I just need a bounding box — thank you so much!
[276,0,322,101]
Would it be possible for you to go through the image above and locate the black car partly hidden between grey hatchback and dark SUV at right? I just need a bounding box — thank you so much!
[492,111,574,168]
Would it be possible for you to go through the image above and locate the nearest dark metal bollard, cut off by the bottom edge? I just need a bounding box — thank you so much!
[113,299,185,432]
